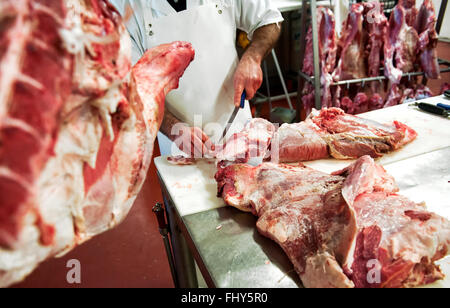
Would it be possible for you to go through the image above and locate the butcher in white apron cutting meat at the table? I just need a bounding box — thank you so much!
[111,0,283,158]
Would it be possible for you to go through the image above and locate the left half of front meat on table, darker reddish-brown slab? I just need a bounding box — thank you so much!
[216,163,356,287]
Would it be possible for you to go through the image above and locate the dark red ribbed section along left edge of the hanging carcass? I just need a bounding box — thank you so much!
[0,0,72,247]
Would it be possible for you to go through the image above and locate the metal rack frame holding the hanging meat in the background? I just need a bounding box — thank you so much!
[297,0,450,121]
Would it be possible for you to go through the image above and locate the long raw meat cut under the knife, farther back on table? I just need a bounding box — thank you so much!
[211,108,417,166]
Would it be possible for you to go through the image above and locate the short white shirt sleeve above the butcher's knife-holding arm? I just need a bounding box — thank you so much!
[235,0,284,40]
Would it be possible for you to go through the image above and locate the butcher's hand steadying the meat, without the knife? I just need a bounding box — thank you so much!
[172,126,214,158]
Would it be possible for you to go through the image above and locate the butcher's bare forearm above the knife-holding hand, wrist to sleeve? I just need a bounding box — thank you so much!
[242,23,281,63]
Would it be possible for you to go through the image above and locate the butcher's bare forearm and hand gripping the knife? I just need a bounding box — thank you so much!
[234,24,281,107]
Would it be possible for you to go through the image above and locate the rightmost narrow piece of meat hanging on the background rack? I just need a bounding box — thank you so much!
[415,0,440,79]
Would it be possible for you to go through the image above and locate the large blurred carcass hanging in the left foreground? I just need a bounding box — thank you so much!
[0,0,194,286]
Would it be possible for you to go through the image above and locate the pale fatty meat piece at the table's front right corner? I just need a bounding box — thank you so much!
[333,157,450,287]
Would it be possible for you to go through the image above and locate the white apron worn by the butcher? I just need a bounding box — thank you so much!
[144,1,255,155]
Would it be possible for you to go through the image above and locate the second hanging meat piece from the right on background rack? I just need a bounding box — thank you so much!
[384,5,419,84]
